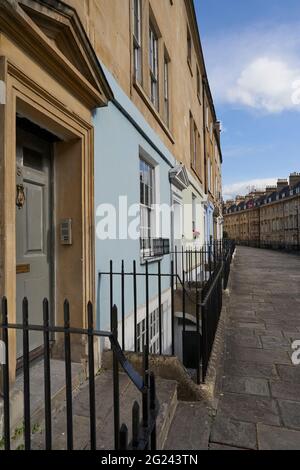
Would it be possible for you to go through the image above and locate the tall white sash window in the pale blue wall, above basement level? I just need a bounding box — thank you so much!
[140,159,154,255]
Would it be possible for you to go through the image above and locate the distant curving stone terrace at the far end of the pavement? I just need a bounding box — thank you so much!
[224,173,300,249]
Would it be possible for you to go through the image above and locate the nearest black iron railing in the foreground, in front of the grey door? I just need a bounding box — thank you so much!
[0,297,159,450]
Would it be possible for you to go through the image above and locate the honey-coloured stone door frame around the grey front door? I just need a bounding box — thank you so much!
[0,57,95,381]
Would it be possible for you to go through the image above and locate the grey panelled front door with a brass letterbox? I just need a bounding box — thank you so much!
[16,129,52,358]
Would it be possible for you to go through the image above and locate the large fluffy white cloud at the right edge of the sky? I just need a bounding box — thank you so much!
[204,23,300,113]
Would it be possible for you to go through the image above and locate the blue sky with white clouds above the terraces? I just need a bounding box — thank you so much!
[194,0,300,199]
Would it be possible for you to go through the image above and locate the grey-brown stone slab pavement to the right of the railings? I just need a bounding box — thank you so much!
[209,247,300,450]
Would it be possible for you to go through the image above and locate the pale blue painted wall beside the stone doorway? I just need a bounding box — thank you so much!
[94,68,175,329]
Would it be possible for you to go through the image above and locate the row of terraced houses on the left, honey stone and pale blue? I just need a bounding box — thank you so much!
[0,0,223,412]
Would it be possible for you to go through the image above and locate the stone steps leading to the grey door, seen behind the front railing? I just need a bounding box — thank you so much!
[32,371,177,450]
